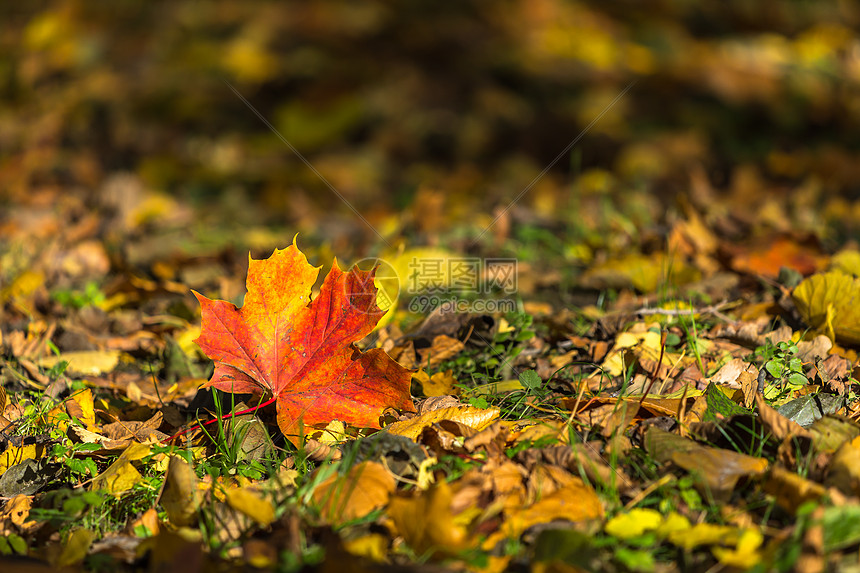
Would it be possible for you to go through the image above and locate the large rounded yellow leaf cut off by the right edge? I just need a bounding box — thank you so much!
[791,271,860,344]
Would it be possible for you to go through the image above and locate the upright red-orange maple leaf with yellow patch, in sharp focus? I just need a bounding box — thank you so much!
[192,243,415,443]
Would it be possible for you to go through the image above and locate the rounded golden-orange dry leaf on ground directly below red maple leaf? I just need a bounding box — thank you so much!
[313,461,395,525]
